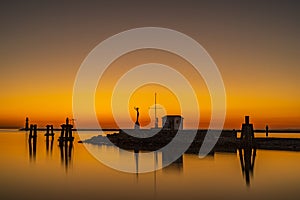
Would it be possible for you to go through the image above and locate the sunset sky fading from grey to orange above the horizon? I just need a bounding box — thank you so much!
[0,1,300,129]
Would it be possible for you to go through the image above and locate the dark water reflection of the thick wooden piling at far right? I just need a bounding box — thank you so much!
[239,146,256,186]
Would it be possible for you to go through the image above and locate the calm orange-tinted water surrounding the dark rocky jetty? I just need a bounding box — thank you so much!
[0,130,300,199]
